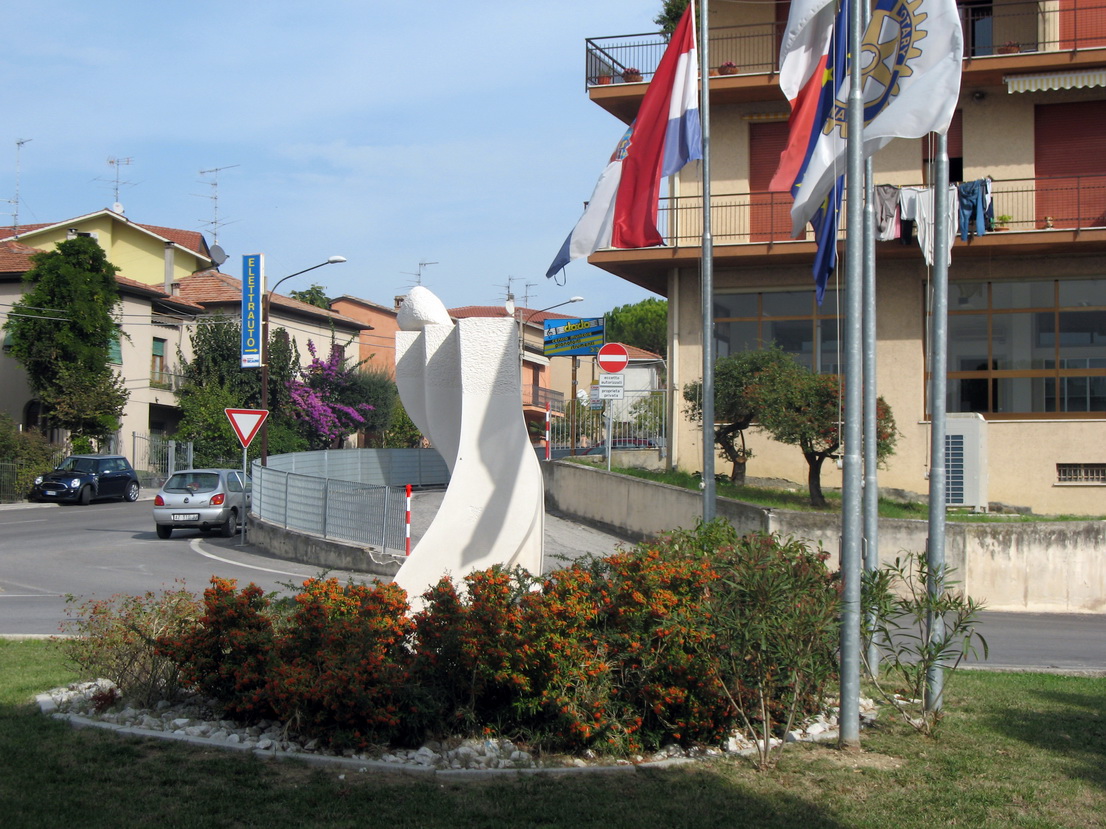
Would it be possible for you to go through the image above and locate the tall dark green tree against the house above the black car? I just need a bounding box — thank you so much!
[4,237,128,440]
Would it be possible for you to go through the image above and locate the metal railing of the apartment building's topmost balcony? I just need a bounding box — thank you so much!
[585,0,1106,86]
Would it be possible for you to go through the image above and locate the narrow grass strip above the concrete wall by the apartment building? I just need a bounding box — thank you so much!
[577,461,1106,524]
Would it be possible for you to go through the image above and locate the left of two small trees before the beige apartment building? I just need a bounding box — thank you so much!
[684,347,794,485]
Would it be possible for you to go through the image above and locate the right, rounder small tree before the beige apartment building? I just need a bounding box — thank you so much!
[750,358,898,506]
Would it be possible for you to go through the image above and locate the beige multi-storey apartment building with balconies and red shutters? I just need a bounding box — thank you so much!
[585,0,1106,514]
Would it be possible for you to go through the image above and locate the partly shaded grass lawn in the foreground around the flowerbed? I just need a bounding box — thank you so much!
[0,640,1106,829]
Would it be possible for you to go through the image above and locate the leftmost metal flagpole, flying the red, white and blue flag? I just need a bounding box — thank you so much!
[699,0,716,522]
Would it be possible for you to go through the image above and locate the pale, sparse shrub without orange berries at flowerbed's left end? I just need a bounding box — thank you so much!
[60,584,199,705]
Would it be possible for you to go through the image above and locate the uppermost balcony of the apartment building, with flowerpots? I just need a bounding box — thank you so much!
[585,0,1106,124]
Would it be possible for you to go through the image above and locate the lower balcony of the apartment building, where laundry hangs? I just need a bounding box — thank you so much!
[588,176,1106,294]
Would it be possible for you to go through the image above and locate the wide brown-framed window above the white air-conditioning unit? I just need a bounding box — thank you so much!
[946,279,1106,418]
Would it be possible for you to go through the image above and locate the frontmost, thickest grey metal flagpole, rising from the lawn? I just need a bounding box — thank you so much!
[838,0,864,748]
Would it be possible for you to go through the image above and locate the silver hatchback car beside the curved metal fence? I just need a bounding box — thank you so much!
[154,469,253,538]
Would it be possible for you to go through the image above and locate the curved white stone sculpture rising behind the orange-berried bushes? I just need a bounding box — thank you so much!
[395,286,545,607]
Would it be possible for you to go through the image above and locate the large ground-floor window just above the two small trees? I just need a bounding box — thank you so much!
[714,288,841,374]
